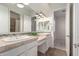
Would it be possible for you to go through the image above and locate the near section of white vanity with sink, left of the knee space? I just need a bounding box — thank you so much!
[0,37,37,56]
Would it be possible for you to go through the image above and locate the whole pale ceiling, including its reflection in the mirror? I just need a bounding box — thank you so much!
[2,3,66,16]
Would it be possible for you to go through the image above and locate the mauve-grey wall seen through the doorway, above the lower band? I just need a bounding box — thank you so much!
[55,15,65,40]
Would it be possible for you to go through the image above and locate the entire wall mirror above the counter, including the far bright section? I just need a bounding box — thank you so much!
[0,3,51,34]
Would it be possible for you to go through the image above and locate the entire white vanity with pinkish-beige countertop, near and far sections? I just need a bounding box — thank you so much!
[0,33,50,56]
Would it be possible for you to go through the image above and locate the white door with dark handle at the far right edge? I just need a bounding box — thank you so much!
[73,3,79,56]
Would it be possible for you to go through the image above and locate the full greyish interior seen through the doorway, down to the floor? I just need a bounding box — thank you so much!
[54,10,65,48]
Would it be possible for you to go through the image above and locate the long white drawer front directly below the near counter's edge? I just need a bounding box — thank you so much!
[0,42,36,56]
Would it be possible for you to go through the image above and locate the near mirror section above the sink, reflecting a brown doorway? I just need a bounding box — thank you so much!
[0,3,32,35]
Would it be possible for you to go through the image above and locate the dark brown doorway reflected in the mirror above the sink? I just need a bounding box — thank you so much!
[10,11,20,32]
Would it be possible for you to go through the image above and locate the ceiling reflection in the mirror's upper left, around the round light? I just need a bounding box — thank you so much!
[1,3,33,15]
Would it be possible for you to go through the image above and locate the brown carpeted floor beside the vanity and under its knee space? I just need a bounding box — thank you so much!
[38,48,66,56]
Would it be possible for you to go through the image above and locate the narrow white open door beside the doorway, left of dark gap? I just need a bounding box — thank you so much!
[65,4,70,56]
